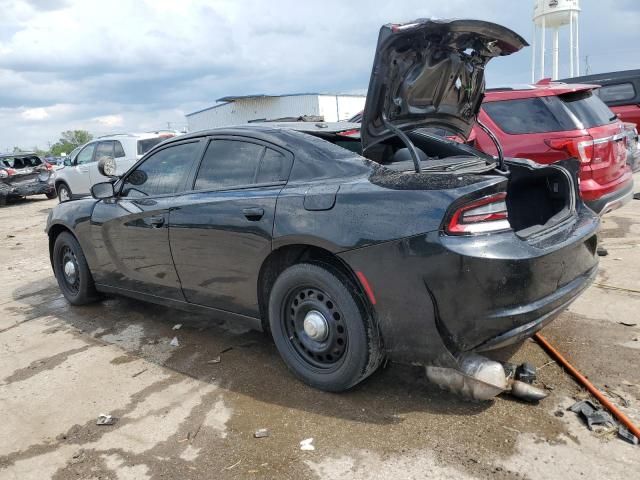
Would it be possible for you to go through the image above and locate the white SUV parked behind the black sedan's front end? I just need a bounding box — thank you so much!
[55,132,176,202]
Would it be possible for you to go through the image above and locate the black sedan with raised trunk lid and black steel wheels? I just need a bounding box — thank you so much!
[47,21,598,391]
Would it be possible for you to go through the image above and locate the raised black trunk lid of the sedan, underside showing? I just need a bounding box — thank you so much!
[362,20,528,150]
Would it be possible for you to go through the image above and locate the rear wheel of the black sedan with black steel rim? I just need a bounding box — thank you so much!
[269,263,382,392]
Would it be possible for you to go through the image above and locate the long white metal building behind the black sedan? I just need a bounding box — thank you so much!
[186,93,366,132]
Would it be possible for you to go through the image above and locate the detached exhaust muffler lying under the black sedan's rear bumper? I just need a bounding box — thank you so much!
[425,353,548,402]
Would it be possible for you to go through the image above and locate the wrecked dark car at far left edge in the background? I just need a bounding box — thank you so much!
[0,152,56,205]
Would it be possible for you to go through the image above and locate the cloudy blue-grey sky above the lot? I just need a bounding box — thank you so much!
[0,0,640,151]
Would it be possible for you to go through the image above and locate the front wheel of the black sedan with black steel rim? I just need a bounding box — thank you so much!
[52,232,98,305]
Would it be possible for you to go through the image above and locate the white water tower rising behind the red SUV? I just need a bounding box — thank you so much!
[531,0,580,82]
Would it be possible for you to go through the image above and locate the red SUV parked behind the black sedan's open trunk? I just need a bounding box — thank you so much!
[470,81,633,214]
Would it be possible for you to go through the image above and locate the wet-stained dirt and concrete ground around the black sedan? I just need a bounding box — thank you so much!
[0,181,640,480]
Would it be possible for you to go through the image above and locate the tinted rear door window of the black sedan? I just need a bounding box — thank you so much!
[194,140,265,190]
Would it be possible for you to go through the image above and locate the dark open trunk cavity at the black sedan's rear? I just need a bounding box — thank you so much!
[506,164,575,237]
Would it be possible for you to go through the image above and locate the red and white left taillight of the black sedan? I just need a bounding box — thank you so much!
[446,192,511,235]
